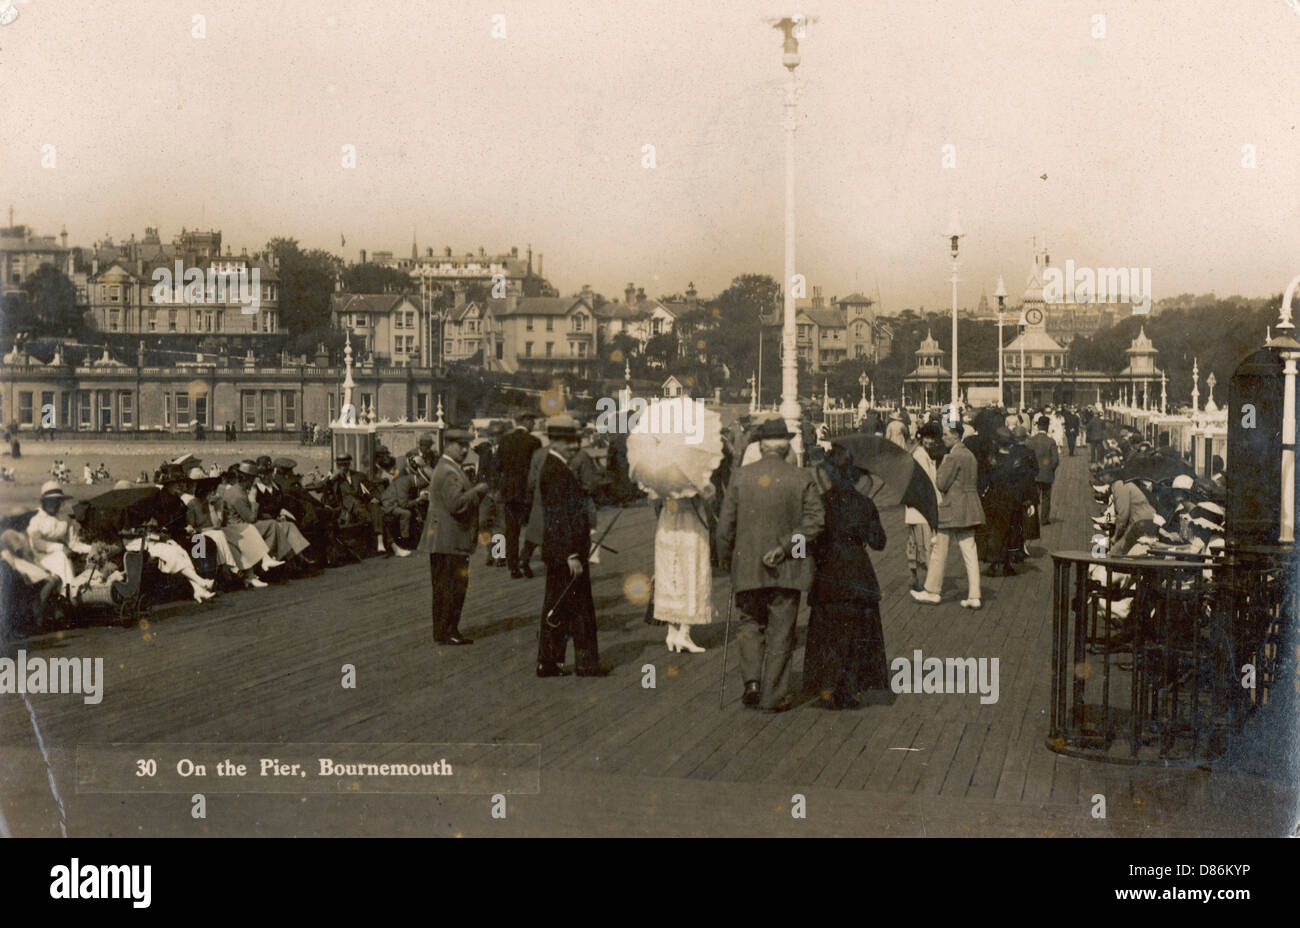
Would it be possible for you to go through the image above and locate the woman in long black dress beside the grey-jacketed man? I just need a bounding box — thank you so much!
[803,446,893,708]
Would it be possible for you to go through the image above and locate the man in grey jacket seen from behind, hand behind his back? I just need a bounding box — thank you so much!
[718,419,826,712]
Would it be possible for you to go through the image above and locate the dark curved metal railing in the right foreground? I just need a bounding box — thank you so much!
[1048,548,1297,764]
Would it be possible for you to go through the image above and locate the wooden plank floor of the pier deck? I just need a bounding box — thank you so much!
[0,444,1275,834]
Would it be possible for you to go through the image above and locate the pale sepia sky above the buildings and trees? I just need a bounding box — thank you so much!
[0,0,1300,309]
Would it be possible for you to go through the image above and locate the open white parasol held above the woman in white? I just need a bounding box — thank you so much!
[628,398,723,499]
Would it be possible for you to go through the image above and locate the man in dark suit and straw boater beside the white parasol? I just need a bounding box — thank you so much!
[537,416,607,677]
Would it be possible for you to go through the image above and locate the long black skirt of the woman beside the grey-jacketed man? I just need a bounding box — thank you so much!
[803,600,889,699]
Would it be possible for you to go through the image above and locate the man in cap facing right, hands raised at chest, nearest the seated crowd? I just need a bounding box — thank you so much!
[417,429,488,645]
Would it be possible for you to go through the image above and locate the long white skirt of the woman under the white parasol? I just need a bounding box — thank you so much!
[654,499,714,625]
